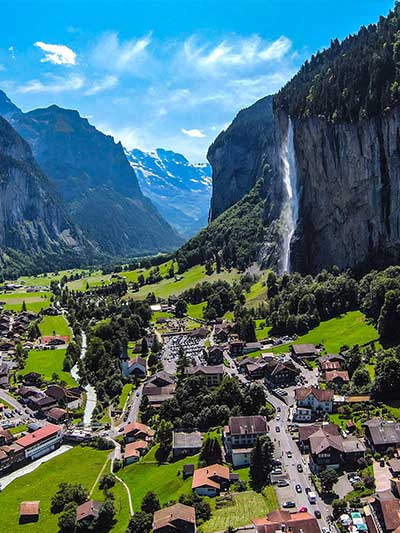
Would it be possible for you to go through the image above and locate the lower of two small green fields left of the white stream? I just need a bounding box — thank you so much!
[18,349,77,387]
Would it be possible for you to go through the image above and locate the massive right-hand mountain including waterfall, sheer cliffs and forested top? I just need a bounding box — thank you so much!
[182,5,400,273]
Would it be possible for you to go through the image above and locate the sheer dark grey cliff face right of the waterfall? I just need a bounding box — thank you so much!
[291,108,400,272]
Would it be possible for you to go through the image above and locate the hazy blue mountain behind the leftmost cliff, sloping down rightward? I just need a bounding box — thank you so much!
[0,93,182,258]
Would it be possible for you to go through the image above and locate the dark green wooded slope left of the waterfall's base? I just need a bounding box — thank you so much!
[176,180,264,272]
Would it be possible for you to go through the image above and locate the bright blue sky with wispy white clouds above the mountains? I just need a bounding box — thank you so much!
[0,0,393,161]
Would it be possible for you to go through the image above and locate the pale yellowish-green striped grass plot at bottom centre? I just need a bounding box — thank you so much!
[202,487,278,533]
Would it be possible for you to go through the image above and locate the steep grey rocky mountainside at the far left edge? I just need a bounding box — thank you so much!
[0,117,91,275]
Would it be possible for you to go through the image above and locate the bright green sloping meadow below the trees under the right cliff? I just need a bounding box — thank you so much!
[272,311,380,353]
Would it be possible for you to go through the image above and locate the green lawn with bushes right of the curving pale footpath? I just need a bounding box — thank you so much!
[118,448,198,511]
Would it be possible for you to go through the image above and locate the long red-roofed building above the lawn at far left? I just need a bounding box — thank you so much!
[15,424,63,461]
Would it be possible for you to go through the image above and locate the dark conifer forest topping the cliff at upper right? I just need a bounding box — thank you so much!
[274,2,400,122]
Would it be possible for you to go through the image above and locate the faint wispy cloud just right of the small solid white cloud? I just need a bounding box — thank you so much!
[92,32,151,72]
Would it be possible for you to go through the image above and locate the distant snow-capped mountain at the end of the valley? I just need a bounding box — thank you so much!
[126,148,211,238]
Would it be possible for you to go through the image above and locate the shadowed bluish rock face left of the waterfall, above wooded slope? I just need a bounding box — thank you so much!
[207,96,274,220]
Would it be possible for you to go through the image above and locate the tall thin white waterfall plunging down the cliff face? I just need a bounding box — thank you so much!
[281,117,299,272]
